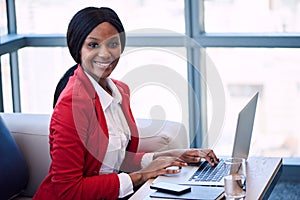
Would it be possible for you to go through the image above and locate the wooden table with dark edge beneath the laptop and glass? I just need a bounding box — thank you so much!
[130,157,282,200]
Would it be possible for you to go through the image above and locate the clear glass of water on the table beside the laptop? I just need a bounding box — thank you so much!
[224,158,246,199]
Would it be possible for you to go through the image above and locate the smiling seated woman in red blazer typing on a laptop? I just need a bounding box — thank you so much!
[33,7,218,200]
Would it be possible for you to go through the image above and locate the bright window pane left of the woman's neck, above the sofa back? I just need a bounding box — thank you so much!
[19,47,74,113]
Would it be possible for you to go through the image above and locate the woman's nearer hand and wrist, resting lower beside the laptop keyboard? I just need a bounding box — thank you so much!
[129,156,187,187]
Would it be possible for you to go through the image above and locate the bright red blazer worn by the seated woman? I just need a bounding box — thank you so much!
[33,66,144,200]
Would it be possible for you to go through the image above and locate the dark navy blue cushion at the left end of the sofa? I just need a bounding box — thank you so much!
[0,116,29,199]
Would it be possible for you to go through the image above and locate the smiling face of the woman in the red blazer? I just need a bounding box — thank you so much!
[80,22,121,83]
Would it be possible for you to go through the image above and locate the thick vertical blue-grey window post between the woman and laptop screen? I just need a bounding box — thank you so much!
[185,0,206,148]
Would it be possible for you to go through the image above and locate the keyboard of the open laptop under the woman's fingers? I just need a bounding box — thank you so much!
[189,159,227,182]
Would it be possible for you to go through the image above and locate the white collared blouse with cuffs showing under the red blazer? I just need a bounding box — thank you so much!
[85,72,153,198]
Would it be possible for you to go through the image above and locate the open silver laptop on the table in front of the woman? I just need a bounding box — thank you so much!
[153,92,259,186]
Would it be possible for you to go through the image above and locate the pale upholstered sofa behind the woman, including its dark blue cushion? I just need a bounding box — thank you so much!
[0,113,189,200]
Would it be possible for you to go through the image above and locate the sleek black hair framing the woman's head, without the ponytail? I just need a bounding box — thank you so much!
[67,7,126,64]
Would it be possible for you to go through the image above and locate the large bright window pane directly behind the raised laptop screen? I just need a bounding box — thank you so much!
[206,48,300,157]
